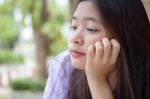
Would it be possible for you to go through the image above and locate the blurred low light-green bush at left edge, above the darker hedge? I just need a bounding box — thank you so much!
[0,50,23,64]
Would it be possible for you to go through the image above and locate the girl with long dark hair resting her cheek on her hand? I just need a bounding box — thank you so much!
[43,0,150,99]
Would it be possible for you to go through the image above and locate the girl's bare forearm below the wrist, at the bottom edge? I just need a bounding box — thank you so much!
[88,80,114,99]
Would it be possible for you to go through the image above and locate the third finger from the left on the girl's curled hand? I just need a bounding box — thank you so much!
[102,37,111,62]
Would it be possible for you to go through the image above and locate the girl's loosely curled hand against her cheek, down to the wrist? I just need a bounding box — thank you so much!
[85,37,120,81]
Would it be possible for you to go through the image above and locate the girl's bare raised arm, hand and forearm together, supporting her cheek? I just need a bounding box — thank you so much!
[85,38,120,99]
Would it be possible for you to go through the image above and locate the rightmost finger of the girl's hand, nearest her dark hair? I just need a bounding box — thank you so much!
[111,39,120,64]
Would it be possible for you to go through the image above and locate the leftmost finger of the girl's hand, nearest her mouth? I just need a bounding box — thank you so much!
[87,45,94,64]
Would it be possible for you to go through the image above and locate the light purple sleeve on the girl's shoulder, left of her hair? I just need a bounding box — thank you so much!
[43,52,70,99]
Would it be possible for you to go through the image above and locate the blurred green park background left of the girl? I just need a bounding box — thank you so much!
[0,0,77,99]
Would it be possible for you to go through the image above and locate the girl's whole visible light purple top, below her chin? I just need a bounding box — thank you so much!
[43,51,73,99]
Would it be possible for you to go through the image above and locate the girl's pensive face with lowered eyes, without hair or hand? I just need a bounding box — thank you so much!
[68,1,108,69]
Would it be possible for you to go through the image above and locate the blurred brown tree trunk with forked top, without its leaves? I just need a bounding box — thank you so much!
[31,0,51,78]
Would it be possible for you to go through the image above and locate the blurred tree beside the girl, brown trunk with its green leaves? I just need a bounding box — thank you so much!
[17,0,68,78]
